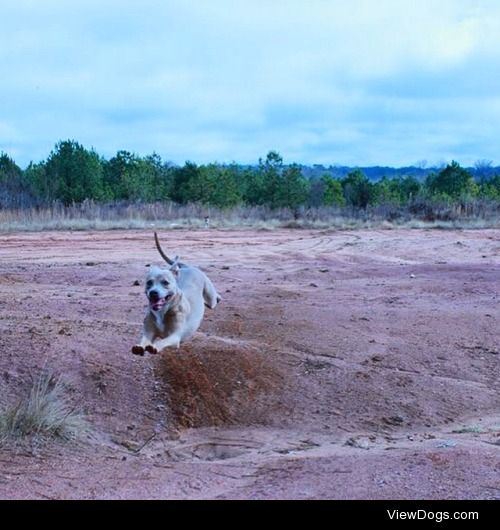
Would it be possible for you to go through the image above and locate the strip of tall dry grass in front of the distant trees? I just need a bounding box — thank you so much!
[0,201,500,232]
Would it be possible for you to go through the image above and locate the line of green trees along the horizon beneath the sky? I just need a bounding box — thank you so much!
[0,140,500,209]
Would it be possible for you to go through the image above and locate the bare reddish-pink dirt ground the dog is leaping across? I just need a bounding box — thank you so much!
[0,229,500,499]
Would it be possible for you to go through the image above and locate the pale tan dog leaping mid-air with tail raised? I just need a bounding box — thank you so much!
[132,232,221,355]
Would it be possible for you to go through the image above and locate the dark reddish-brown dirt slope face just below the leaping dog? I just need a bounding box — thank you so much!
[159,341,283,427]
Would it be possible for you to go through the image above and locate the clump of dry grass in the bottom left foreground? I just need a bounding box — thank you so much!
[0,373,90,443]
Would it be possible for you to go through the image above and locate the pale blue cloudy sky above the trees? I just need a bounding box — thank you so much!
[0,0,500,167]
